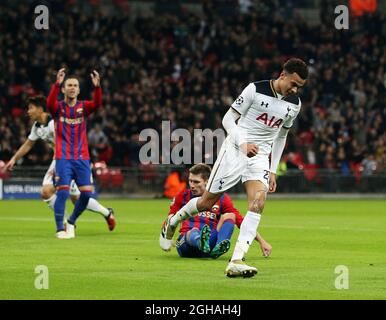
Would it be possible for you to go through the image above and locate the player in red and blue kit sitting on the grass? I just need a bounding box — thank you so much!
[160,164,272,259]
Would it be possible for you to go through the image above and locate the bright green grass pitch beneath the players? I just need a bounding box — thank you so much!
[0,199,386,300]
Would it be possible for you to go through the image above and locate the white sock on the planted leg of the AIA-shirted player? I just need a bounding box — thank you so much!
[231,211,261,261]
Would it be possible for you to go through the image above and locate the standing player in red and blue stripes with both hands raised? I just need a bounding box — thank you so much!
[47,68,110,239]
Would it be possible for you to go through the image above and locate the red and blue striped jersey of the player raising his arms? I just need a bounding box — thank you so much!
[47,83,102,160]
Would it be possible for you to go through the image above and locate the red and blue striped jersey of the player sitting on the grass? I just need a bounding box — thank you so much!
[169,189,243,234]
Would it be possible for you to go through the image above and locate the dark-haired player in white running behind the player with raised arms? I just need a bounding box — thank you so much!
[3,96,115,235]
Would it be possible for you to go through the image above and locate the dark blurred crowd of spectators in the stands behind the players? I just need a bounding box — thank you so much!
[0,0,386,174]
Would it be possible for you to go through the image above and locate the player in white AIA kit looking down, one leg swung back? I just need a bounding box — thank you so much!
[160,58,308,277]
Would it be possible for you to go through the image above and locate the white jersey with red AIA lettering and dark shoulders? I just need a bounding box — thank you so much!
[232,80,301,155]
